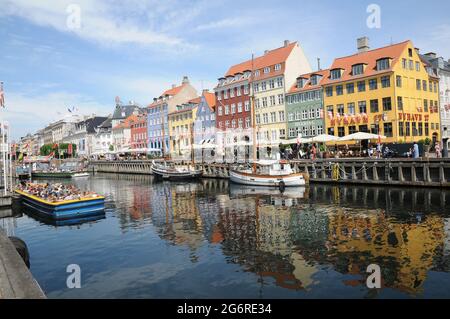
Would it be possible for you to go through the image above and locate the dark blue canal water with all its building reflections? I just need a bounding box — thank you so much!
[0,174,450,298]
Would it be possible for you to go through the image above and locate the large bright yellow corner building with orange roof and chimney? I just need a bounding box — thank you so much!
[322,38,440,143]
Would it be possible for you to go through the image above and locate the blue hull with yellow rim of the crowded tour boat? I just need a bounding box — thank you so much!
[15,190,105,220]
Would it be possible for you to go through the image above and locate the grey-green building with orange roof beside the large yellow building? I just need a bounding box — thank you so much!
[286,70,328,139]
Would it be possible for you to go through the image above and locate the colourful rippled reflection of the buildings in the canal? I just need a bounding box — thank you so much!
[145,180,450,294]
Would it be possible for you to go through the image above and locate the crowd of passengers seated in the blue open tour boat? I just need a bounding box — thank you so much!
[18,183,98,203]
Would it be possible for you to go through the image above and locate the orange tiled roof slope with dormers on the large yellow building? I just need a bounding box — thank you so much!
[322,41,411,85]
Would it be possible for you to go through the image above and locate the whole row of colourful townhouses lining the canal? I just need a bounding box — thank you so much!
[19,38,450,157]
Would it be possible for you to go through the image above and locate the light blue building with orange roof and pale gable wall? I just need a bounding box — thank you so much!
[147,76,198,155]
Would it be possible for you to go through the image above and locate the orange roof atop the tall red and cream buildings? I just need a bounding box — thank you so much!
[225,42,297,77]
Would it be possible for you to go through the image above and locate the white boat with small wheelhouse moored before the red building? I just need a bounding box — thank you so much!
[230,161,306,188]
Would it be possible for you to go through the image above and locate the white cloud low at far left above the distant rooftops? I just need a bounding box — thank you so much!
[3,92,112,140]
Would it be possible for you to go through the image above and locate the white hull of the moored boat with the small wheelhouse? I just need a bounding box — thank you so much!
[230,171,306,187]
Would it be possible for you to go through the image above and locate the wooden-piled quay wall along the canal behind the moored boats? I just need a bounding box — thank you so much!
[90,158,450,188]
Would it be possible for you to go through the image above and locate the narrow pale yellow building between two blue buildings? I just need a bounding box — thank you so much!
[169,97,200,159]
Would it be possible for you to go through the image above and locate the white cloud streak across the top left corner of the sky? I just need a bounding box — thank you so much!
[0,0,189,47]
